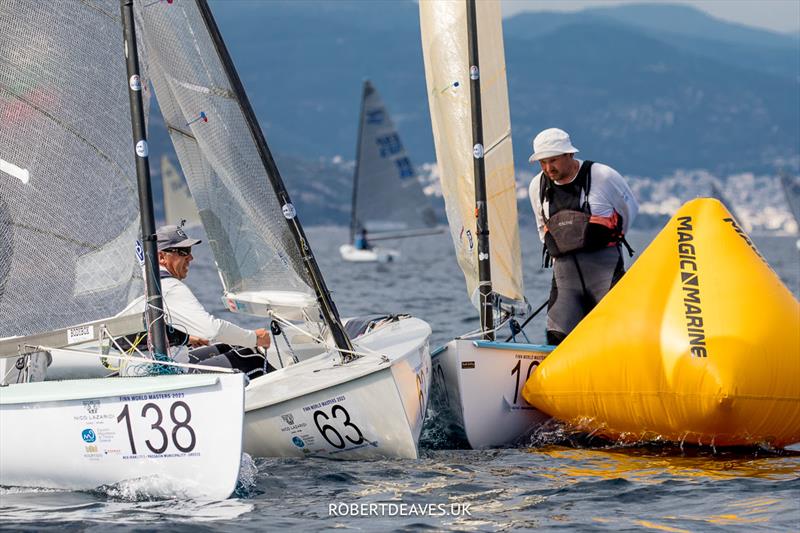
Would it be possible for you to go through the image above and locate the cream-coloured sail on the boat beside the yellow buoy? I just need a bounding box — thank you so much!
[420,0,524,307]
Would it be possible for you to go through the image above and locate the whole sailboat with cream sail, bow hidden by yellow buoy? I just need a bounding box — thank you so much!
[419,0,552,448]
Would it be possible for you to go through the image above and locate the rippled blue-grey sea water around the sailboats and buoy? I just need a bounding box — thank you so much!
[0,227,800,532]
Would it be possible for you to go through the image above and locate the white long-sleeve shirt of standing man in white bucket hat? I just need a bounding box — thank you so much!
[528,159,639,242]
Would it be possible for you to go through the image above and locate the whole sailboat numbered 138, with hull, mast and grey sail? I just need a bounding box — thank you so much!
[0,0,244,499]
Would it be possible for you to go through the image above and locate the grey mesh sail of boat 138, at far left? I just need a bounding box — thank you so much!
[0,0,143,337]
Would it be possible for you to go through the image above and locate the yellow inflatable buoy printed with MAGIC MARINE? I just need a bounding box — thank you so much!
[522,198,800,447]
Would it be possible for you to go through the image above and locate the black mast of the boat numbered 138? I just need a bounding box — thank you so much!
[120,0,168,356]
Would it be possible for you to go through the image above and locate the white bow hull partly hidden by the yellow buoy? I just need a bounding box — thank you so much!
[431,339,551,449]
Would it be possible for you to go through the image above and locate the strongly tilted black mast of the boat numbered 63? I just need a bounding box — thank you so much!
[194,0,353,359]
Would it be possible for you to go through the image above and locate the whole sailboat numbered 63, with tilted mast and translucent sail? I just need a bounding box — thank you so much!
[140,0,431,459]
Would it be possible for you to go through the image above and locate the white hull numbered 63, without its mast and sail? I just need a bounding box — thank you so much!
[244,318,431,459]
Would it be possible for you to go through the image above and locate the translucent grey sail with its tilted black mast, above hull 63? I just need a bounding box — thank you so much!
[139,0,353,352]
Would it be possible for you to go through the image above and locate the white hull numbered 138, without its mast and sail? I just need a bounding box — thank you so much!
[0,374,244,500]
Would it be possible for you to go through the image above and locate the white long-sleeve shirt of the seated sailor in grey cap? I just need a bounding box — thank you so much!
[120,269,256,347]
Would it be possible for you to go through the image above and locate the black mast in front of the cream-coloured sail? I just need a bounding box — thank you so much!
[466,0,494,340]
